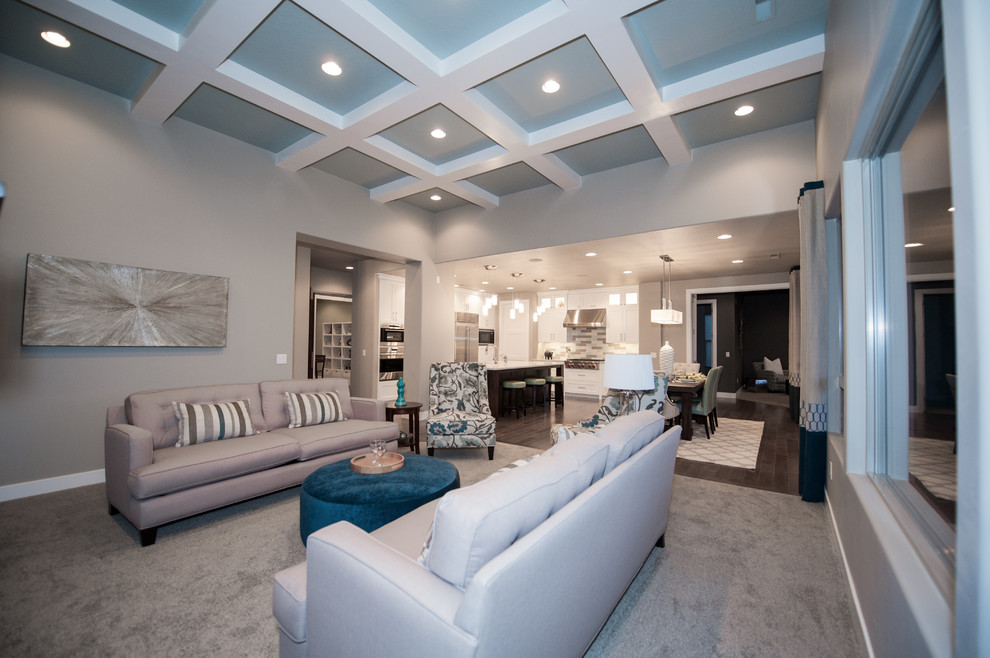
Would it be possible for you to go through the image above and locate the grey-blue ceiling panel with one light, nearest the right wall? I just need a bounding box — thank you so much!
[675,74,821,148]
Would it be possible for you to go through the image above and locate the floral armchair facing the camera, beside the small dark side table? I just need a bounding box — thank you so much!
[426,361,495,459]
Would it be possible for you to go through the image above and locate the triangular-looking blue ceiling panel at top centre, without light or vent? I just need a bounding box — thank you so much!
[370,0,548,59]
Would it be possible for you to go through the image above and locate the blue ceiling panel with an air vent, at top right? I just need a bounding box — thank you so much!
[625,0,828,87]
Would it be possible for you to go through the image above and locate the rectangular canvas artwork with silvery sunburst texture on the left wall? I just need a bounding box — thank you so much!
[21,254,228,347]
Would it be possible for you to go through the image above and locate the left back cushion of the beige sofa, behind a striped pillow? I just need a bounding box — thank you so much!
[124,384,266,448]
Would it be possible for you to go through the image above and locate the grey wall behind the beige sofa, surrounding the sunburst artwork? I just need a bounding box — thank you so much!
[0,56,435,486]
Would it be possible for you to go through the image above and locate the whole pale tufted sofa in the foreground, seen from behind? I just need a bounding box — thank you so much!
[273,411,681,658]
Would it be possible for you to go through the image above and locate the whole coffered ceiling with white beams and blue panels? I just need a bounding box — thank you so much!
[0,0,826,211]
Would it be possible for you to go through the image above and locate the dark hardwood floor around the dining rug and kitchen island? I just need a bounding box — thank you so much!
[496,397,799,495]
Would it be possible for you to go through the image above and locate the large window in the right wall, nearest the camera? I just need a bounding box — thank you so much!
[863,8,956,584]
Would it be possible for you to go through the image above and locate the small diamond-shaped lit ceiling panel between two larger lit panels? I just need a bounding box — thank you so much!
[378,105,504,165]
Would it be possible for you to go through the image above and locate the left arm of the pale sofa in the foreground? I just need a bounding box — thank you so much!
[306,522,477,656]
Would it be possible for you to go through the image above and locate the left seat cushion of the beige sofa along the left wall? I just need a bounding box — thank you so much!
[127,432,299,499]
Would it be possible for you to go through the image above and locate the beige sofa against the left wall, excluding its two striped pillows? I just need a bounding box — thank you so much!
[104,379,399,546]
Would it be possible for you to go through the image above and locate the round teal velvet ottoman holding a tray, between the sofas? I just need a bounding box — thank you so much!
[299,454,461,544]
